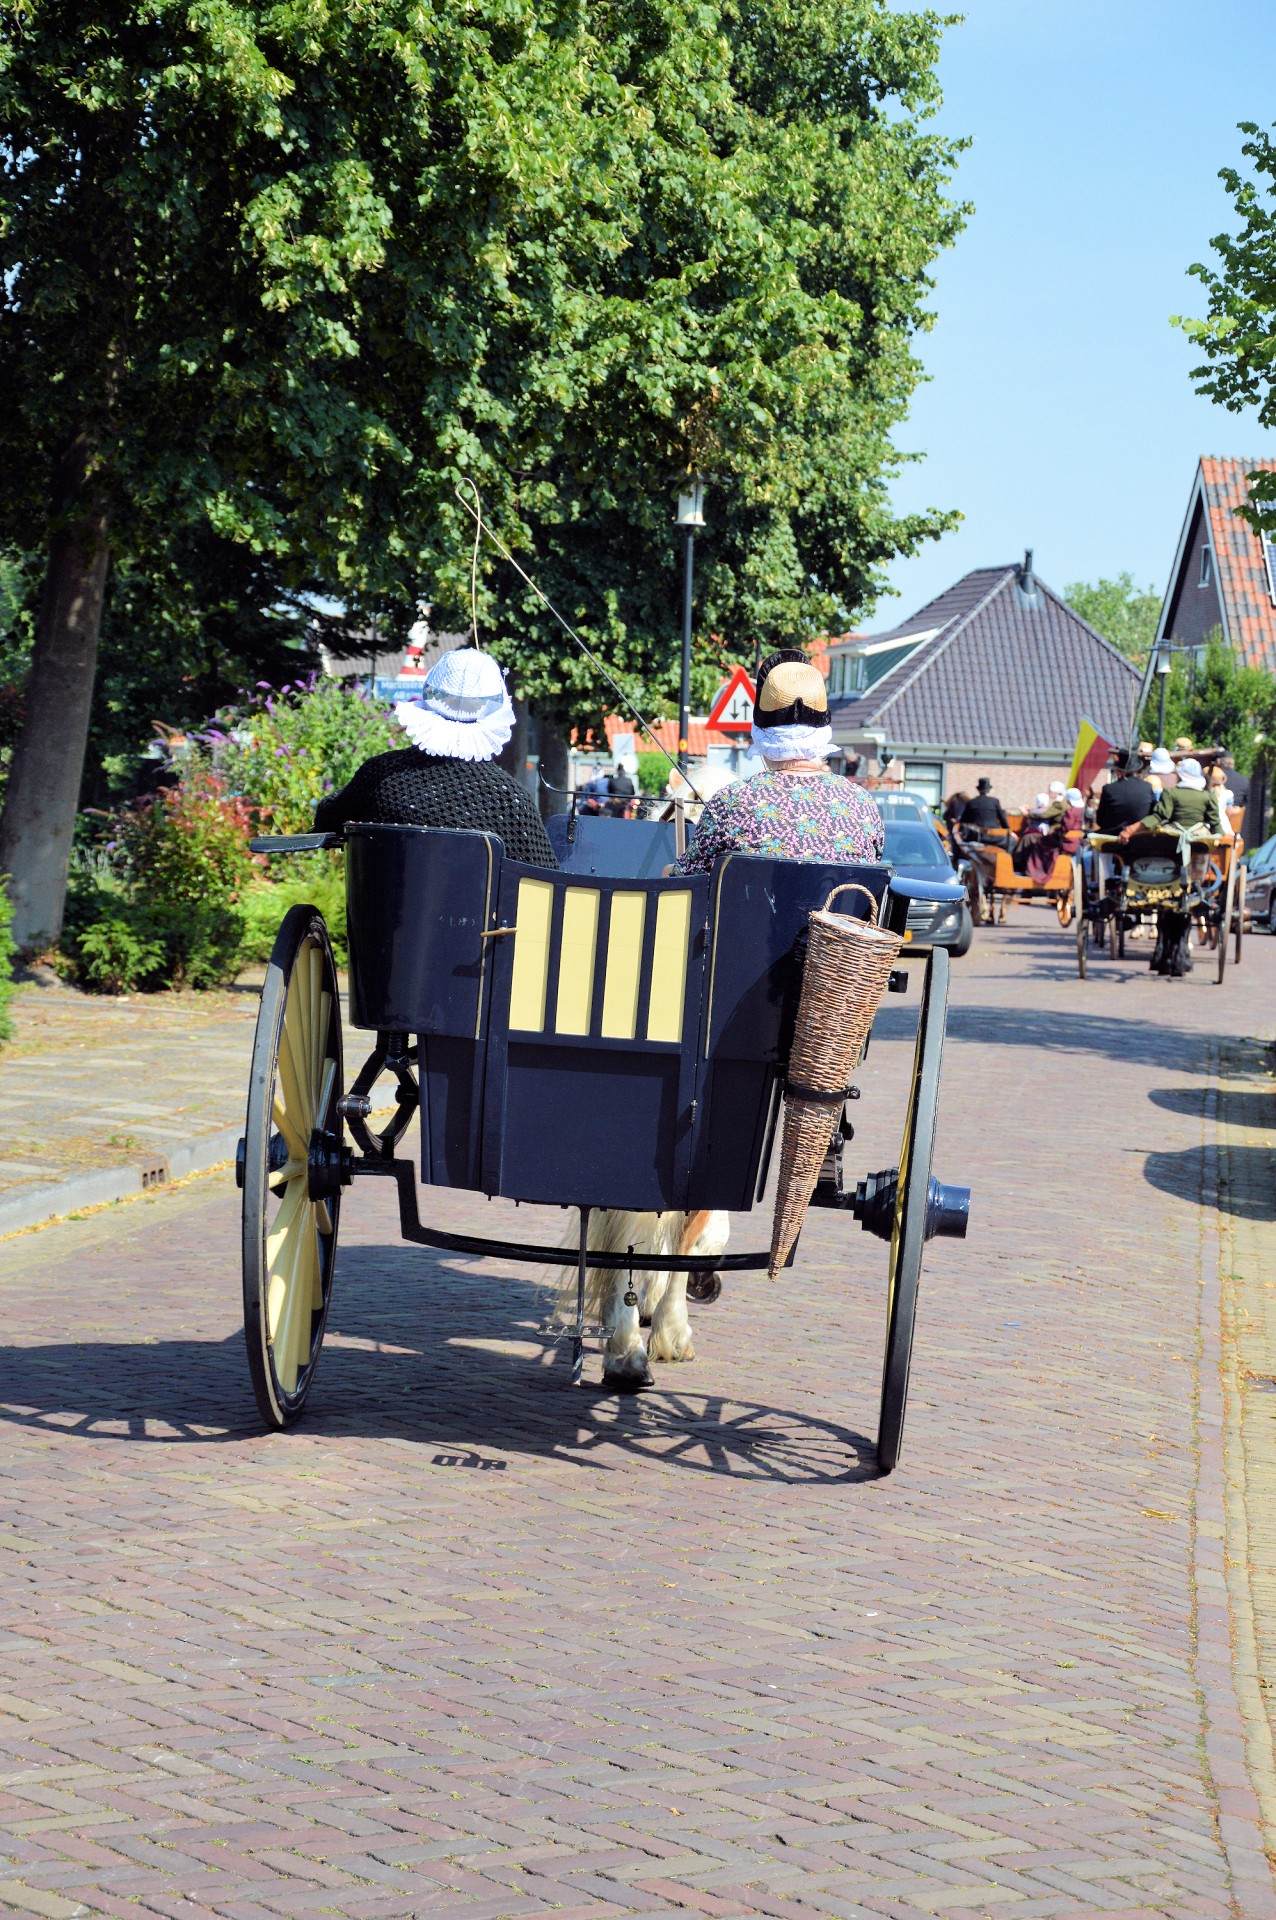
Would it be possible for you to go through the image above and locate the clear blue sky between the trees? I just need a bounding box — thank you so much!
[862,0,1276,630]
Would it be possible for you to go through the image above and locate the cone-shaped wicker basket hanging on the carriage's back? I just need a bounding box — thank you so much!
[768,883,902,1279]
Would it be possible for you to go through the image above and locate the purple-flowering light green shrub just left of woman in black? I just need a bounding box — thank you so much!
[201,674,407,833]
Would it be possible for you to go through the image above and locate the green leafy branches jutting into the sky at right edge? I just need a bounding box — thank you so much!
[1172,121,1276,530]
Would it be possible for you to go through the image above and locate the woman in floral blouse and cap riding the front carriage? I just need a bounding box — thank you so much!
[673,647,883,874]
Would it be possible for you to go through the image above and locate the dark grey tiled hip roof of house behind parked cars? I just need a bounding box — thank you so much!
[833,566,1140,760]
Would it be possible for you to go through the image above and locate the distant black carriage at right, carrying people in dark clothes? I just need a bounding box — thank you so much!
[1073,829,1245,985]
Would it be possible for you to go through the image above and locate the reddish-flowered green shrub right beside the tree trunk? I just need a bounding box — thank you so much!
[63,758,261,993]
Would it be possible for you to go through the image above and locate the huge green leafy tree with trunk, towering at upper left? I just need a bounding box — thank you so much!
[0,0,961,945]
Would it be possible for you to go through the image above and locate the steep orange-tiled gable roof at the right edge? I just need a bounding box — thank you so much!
[1157,455,1276,672]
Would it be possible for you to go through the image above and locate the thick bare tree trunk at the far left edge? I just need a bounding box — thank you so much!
[0,434,107,954]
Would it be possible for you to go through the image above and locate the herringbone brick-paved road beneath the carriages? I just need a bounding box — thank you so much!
[0,912,1276,1920]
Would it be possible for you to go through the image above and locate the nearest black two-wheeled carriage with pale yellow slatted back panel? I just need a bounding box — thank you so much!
[238,818,969,1471]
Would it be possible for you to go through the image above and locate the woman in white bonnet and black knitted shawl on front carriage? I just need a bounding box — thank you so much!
[315,647,558,866]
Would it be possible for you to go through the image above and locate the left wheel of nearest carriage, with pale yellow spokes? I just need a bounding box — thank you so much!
[242,906,342,1427]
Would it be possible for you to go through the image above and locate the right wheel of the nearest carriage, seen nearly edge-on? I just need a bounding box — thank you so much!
[877,947,948,1473]
